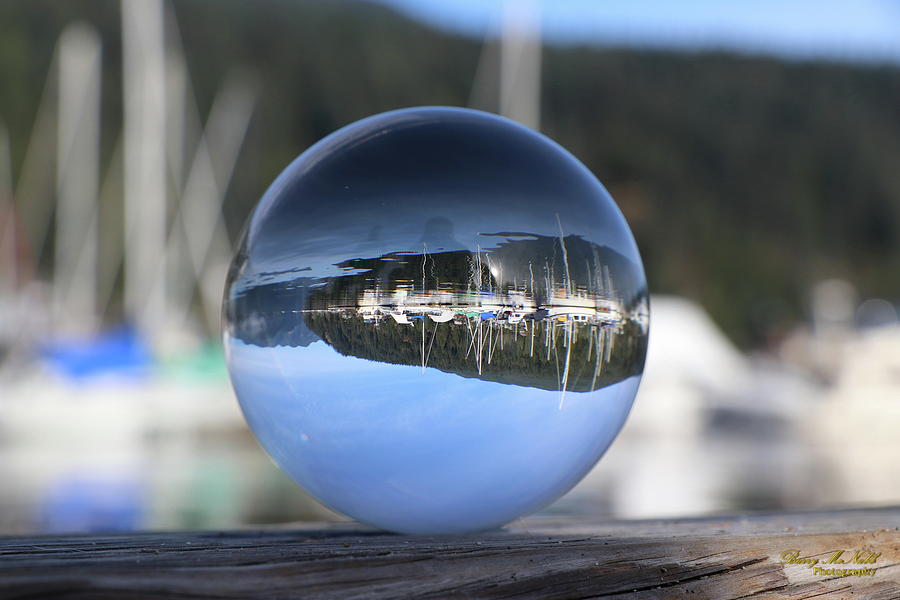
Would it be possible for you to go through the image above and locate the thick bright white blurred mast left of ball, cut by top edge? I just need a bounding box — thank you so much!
[121,0,167,340]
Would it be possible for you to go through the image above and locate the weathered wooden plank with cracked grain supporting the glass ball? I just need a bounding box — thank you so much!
[0,508,900,599]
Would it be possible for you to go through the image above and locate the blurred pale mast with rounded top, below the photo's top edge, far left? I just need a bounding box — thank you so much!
[52,23,101,333]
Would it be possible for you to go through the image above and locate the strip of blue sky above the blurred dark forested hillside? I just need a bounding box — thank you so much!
[376,0,900,62]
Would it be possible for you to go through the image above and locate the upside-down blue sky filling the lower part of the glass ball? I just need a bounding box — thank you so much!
[226,338,640,533]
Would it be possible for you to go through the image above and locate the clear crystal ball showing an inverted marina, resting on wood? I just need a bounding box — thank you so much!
[223,107,649,533]
